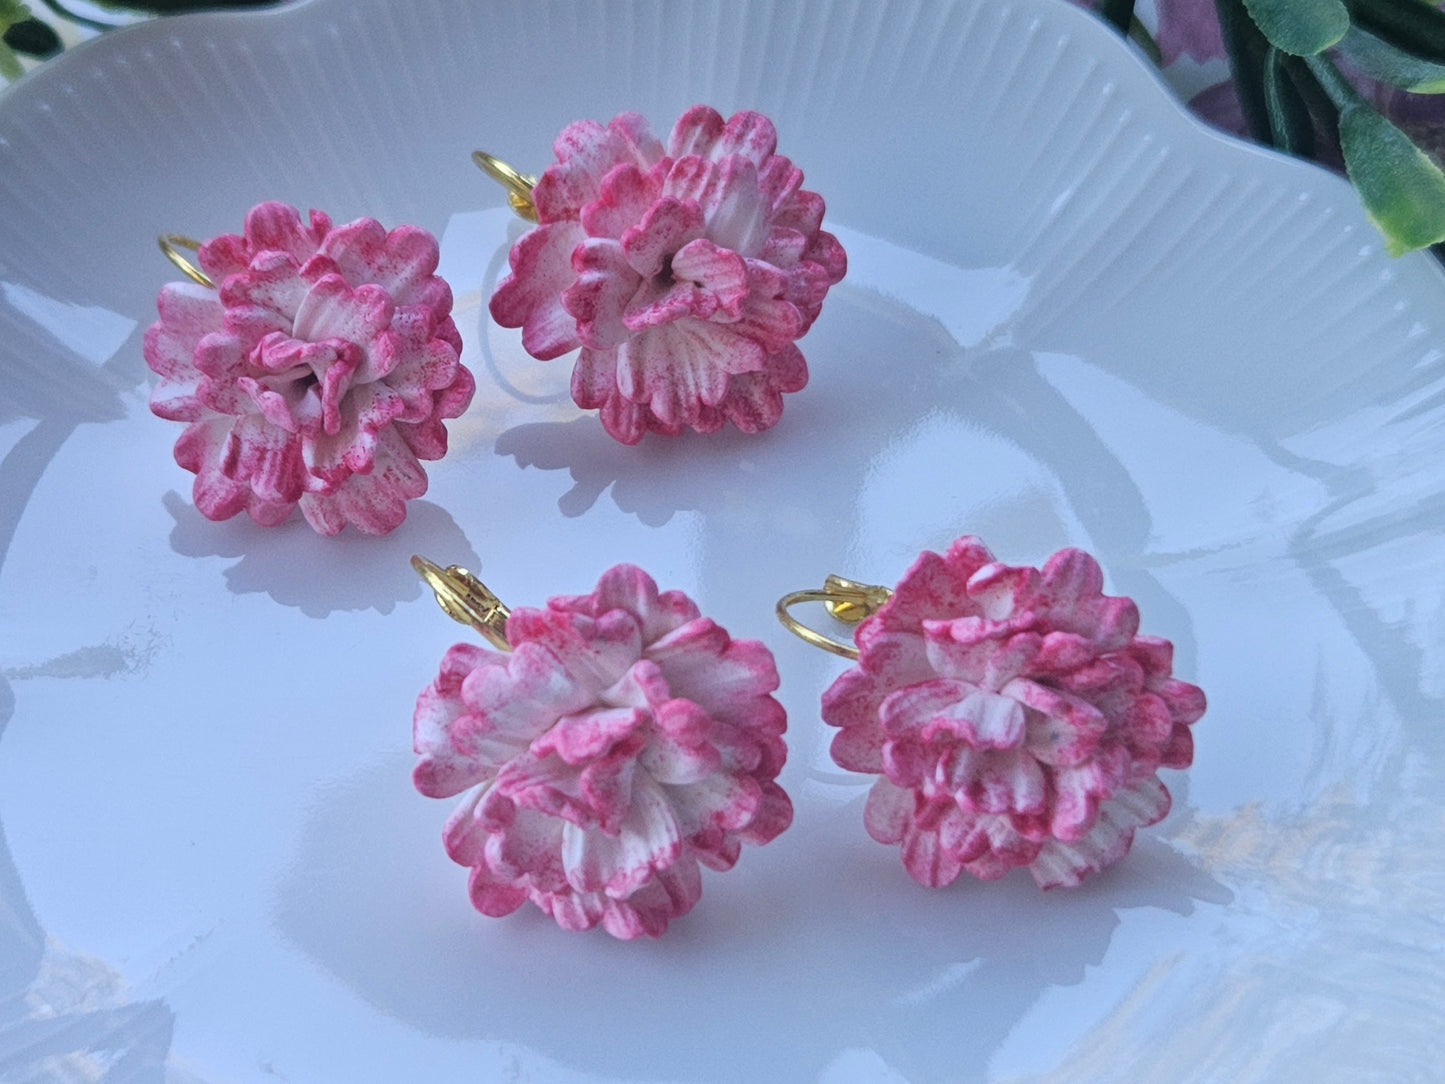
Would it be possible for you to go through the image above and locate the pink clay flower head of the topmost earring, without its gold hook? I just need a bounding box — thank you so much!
[483,106,847,444]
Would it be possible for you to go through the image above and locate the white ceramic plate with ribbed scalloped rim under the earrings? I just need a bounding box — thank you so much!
[0,0,1445,1084]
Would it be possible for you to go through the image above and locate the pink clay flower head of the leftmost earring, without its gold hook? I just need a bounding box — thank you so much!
[145,202,474,535]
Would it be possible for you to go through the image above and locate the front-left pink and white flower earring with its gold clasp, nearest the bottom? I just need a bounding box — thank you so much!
[413,558,792,938]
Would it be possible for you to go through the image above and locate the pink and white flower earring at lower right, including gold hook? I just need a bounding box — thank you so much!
[777,538,1205,887]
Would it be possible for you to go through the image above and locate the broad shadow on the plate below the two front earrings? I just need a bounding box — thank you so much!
[276,756,1231,1081]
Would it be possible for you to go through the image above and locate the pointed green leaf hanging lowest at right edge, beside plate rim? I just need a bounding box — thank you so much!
[1309,56,1445,256]
